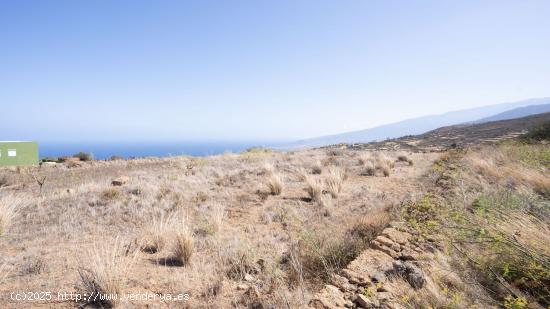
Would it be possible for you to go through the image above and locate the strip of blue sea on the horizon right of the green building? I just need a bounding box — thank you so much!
[38,141,275,160]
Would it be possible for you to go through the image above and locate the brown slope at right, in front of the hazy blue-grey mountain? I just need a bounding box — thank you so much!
[349,113,550,151]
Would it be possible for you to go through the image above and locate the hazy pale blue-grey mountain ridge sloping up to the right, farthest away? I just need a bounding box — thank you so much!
[279,98,550,149]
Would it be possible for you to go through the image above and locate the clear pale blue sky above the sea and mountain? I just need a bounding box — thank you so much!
[0,0,550,141]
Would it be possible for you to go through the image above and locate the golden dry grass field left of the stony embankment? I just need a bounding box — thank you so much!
[0,150,436,308]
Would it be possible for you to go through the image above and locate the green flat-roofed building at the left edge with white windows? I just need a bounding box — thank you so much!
[0,141,38,166]
